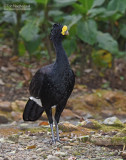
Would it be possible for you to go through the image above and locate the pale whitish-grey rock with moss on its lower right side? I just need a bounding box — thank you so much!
[103,116,124,127]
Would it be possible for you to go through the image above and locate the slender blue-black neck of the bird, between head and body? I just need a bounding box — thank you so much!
[54,41,69,65]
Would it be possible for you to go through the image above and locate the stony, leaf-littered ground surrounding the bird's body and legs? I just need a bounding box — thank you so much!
[0,56,126,160]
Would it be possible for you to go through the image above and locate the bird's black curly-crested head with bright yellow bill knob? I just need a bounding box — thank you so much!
[50,24,69,41]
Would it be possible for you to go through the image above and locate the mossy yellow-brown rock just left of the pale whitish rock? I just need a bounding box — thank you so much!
[79,119,101,129]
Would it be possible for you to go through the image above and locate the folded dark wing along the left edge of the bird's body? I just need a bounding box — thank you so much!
[29,70,44,98]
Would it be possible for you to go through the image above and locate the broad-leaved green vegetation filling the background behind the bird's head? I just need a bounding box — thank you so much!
[0,0,126,69]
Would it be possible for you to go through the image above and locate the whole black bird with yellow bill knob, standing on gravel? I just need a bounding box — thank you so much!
[23,24,75,143]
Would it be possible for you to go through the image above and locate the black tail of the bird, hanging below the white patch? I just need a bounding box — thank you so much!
[23,99,44,121]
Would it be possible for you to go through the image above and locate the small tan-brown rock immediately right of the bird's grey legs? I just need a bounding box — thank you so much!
[59,122,77,132]
